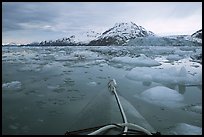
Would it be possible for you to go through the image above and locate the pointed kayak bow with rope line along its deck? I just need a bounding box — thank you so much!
[66,79,159,135]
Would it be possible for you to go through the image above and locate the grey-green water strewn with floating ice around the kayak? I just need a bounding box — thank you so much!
[2,46,202,134]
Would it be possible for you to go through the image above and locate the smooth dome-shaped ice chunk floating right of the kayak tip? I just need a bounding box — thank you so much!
[135,86,184,107]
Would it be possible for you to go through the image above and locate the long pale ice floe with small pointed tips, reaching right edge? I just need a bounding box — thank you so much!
[126,66,202,85]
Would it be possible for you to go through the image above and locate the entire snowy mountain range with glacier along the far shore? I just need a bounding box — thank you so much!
[21,22,202,46]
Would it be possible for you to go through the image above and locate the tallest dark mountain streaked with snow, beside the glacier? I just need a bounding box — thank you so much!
[89,22,155,45]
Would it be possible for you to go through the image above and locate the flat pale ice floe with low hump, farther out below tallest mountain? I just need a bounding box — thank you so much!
[111,54,160,67]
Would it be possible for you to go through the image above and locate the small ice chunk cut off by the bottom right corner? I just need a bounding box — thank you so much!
[169,123,202,135]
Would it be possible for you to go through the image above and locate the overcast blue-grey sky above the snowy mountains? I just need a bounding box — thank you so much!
[2,2,202,43]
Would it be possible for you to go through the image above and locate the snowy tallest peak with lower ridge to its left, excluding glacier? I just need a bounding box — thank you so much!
[26,22,155,45]
